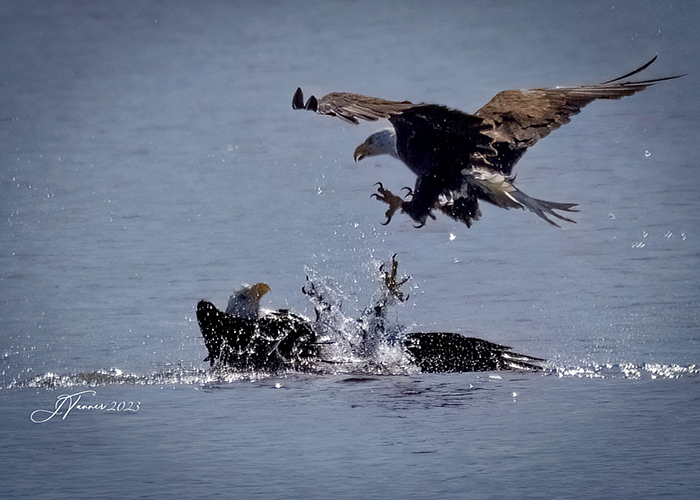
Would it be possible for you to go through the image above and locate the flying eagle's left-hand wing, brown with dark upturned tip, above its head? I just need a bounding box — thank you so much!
[292,88,416,125]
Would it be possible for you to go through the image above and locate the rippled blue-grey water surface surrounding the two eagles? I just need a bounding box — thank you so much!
[0,0,700,498]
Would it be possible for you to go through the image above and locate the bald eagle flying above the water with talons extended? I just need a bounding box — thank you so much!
[292,57,683,227]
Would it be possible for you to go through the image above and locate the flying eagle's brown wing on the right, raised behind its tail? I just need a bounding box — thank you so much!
[475,57,683,175]
